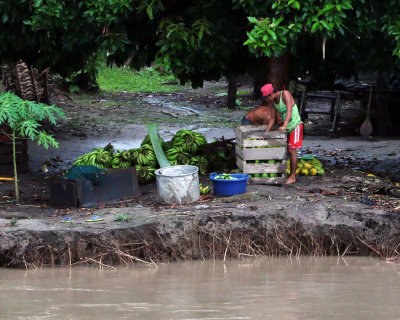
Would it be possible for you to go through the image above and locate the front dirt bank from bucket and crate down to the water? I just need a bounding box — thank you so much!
[0,169,400,268]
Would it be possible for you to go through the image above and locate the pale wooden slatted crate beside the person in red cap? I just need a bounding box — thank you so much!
[235,125,287,184]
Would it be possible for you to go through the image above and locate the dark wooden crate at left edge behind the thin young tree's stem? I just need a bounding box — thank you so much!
[0,139,29,177]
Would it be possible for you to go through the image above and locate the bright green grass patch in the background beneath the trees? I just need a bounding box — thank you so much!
[97,65,188,93]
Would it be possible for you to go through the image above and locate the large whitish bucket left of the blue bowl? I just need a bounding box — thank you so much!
[155,165,200,204]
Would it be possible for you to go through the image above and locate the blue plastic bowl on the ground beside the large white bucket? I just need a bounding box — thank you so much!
[210,172,249,196]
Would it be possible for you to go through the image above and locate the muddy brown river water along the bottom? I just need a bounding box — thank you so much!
[0,257,400,320]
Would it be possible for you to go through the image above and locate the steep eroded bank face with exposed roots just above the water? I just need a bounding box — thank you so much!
[0,219,400,269]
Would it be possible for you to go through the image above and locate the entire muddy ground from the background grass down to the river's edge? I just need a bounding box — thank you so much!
[0,82,400,268]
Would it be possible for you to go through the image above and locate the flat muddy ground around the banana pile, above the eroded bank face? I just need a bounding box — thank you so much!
[0,82,400,265]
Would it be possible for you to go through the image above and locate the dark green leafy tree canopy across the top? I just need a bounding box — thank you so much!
[0,0,400,87]
